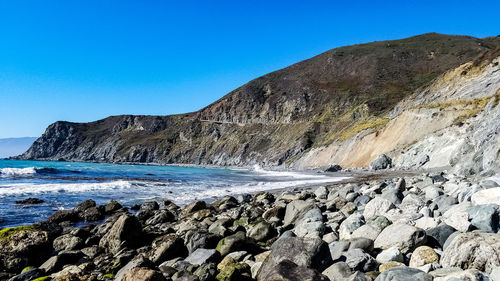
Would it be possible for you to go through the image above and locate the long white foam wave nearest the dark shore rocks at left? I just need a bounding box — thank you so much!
[0,180,132,196]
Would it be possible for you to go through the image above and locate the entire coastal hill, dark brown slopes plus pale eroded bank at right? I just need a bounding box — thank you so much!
[18,33,500,173]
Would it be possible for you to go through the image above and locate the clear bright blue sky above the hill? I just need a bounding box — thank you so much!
[0,0,500,138]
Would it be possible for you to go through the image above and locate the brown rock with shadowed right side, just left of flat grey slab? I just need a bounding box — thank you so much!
[149,233,187,264]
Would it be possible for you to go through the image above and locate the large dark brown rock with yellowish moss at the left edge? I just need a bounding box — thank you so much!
[0,225,52,272]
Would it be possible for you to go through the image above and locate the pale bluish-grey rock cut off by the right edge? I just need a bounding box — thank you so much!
[467,204,499,233]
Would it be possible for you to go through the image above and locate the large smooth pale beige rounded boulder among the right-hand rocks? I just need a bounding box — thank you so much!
[374,224,426,254]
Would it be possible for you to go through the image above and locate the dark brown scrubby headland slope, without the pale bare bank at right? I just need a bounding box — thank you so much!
[20,34,500,171]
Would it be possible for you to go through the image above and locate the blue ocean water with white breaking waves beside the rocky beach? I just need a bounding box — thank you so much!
[0,160,344,228]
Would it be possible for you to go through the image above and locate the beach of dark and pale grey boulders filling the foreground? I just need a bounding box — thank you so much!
[0,163,500,281]
